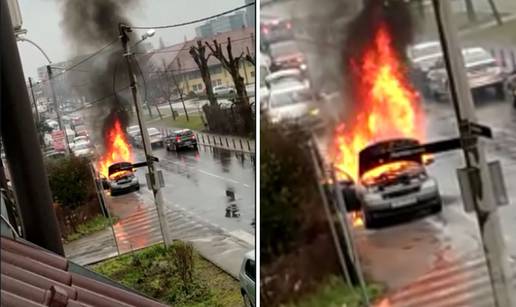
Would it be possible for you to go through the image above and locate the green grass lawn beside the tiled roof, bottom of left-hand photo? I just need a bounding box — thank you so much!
[92,241,243,307]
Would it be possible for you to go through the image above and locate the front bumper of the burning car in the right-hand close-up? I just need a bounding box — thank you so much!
[364,192,441,218]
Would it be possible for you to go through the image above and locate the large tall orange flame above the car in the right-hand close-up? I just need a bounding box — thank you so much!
[334,24,425,180]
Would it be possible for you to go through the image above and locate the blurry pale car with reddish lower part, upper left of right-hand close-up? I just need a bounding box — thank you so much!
[269,40,307,71]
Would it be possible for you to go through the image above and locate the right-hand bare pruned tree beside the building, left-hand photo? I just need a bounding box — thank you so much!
[206,37,249,105]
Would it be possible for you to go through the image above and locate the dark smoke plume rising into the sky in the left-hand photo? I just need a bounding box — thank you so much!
[58,0,138,149]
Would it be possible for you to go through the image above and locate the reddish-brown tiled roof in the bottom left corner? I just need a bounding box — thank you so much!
[0,236,166,307]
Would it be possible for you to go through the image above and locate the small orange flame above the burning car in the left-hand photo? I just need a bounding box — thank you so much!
[98,118,133,178]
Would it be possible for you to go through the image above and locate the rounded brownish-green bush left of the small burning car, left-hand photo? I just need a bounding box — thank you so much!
[47,155,96,210]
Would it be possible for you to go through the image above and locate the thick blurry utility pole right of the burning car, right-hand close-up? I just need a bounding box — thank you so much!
[432,0,516,307]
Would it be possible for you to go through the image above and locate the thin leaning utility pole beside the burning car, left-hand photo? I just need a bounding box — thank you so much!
[118,23,171,246]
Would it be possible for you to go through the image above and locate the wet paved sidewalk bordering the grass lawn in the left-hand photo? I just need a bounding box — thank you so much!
[64,194,254,279]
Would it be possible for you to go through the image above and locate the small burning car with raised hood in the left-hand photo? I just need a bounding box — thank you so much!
[108,162,140,196]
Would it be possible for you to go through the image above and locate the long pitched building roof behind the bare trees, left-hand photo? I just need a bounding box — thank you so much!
[148,27,256,72]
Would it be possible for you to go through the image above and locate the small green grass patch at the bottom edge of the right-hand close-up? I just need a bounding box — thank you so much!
[284,276,381,307]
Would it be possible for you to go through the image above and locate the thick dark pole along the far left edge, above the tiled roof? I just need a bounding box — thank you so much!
[0,1,64,255]
